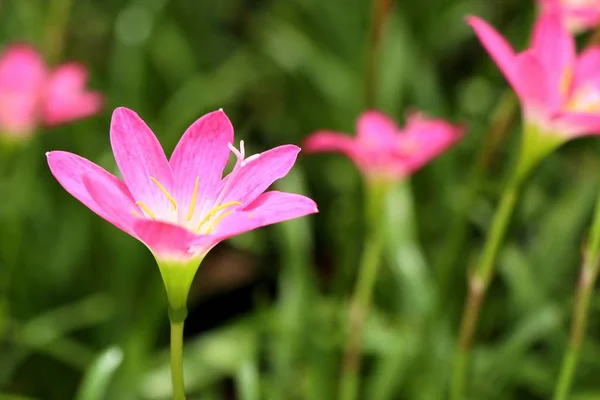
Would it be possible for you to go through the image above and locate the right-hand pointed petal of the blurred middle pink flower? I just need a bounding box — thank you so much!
[402,113,465,174]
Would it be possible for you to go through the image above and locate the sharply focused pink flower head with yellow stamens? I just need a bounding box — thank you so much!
[47,108,317,262]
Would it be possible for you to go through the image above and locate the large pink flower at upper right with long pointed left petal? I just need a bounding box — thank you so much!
[467,13,600,141]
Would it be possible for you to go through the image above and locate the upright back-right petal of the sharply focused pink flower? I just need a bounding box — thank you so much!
[170,110,233,219]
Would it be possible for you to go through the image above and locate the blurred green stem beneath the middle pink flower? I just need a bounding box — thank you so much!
[340,184,387,400]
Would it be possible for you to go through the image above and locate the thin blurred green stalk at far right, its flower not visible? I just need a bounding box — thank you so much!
[553,192,600,400]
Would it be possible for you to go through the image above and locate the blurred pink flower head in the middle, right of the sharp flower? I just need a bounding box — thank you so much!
[304,110,464,180]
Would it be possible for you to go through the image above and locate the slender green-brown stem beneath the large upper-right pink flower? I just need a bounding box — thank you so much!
[451,168,521,400]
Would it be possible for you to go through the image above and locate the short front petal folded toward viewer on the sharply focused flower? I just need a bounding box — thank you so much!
[133,219,205,261]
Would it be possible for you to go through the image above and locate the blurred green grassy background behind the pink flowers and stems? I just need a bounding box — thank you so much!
[0,0,600,400]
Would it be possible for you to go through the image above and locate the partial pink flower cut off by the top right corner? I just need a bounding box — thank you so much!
[539,0,600,33]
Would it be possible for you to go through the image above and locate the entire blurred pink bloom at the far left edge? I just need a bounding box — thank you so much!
[0,44,102,137]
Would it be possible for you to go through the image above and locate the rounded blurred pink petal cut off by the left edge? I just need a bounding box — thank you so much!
[0,45,46,135]
